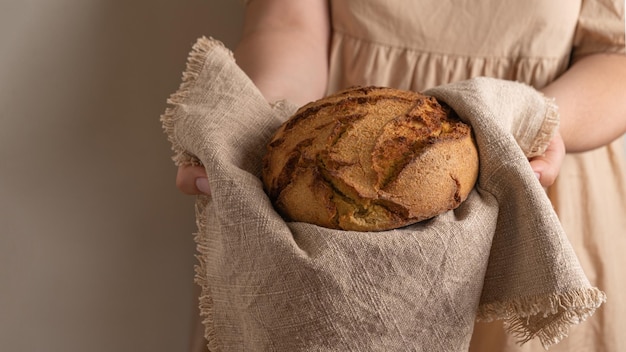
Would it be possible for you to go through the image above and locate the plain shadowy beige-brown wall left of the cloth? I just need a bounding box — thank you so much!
[0,0,242,352]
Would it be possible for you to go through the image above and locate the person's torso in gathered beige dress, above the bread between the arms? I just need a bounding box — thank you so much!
[330,0,580,90]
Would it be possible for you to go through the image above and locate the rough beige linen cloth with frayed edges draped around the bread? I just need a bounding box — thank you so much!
[162,38,604,351]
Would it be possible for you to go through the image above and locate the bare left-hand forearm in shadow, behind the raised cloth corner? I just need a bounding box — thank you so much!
[235,0,330,105]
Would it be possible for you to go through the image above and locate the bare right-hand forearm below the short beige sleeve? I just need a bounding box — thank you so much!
[542,54,626,152]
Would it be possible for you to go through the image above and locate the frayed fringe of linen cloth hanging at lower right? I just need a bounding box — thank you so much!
[476,287,606,350]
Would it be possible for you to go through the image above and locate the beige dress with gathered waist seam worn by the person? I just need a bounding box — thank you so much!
[329,0,626,351]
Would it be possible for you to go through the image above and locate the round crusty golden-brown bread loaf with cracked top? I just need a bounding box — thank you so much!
[263,87,478,231]
